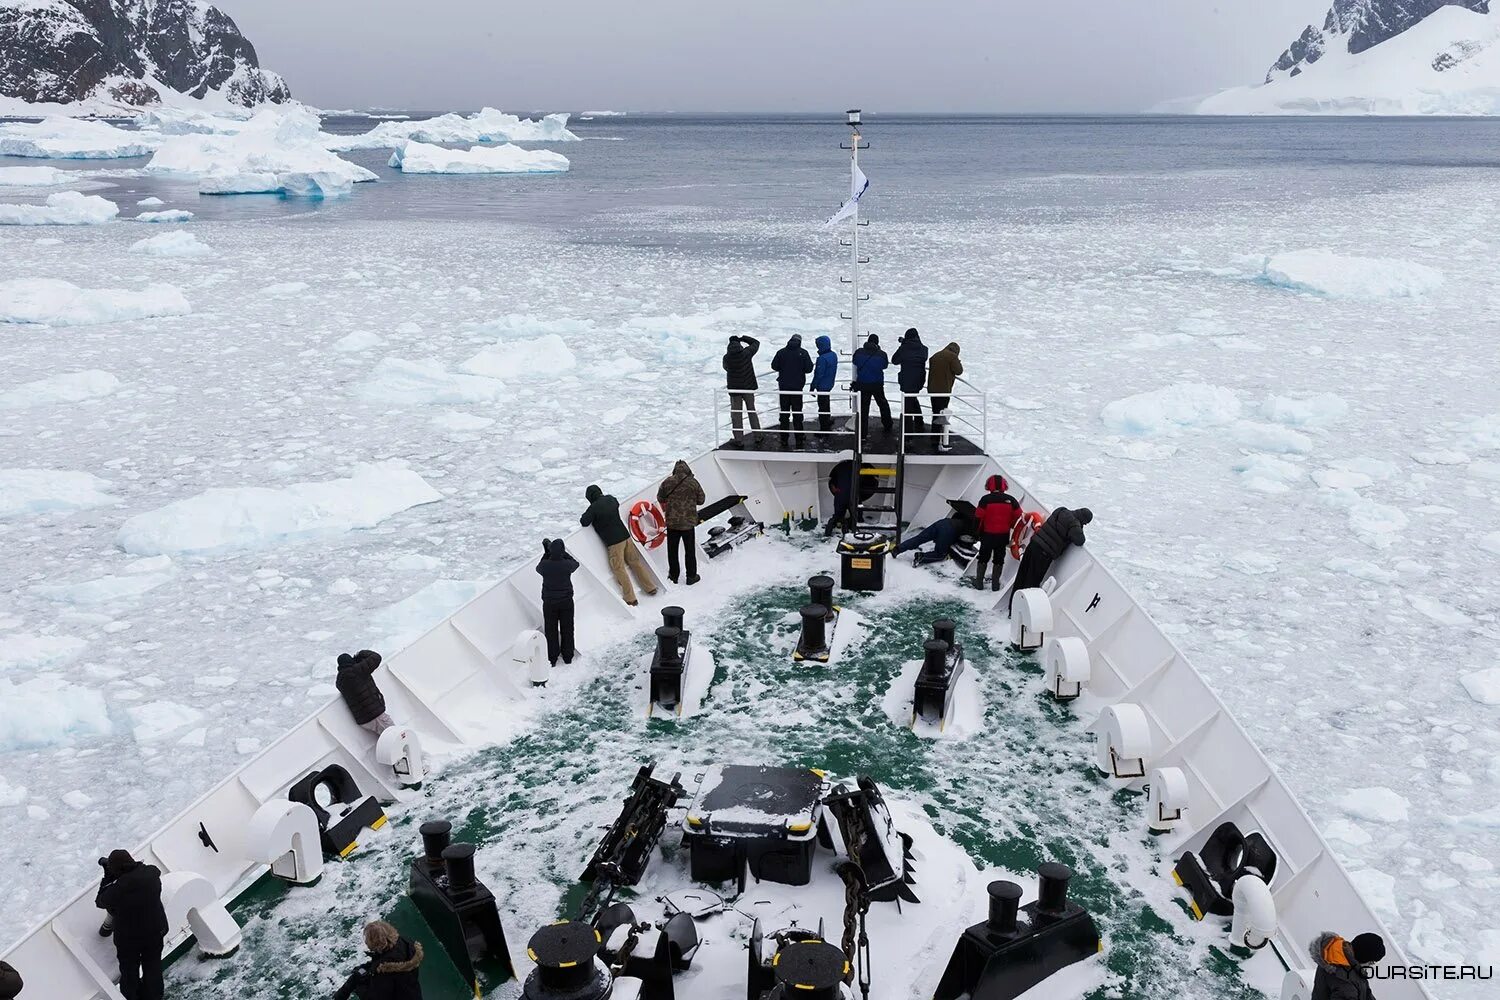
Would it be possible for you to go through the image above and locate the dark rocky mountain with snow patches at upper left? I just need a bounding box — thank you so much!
[0,0,291,108]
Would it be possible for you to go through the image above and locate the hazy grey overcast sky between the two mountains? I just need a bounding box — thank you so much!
[228,0,1331,111]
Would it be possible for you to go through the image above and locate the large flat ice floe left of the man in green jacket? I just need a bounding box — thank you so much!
[117,462,443,555]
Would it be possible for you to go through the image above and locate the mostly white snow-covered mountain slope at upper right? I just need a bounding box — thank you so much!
[1191,0,1500,115]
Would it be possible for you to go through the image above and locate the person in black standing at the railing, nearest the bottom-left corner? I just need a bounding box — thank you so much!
[95,850,168,1000]
